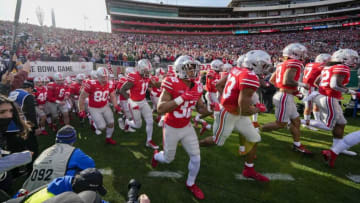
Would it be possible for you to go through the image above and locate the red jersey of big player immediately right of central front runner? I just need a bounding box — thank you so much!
[221,68,260,115]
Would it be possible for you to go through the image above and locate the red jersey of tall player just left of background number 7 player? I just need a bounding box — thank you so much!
[275,59,303,90]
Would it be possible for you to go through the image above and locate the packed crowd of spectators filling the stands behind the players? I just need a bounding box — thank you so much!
[0,21,360,66]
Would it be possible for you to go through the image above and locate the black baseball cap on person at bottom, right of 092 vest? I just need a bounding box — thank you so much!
[72,168,107,196]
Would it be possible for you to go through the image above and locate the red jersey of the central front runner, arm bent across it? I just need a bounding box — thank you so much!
[161,77,203,128]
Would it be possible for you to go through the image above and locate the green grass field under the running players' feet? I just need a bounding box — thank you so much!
[34,100,360,203]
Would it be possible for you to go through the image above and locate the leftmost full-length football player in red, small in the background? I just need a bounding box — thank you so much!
[34,76,48,135]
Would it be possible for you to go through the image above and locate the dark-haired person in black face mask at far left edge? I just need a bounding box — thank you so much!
[0,95,32,201]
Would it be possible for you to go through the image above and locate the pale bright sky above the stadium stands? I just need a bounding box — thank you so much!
[0,0,230,32]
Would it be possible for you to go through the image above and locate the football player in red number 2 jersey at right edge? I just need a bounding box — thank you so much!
[312,49,359,156]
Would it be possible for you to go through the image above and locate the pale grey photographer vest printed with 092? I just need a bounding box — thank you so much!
[22,143,75,191]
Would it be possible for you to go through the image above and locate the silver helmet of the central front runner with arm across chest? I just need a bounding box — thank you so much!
[174,55,200,79]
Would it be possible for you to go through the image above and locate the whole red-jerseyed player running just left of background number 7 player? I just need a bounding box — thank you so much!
[261,43,312,155]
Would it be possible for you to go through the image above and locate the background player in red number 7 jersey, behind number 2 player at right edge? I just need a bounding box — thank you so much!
[301,54,331,130]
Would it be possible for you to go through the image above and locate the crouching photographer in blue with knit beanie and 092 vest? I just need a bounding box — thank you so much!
[22,125,95,191]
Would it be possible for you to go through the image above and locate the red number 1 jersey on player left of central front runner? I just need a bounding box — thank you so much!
[127,72,149,101]
